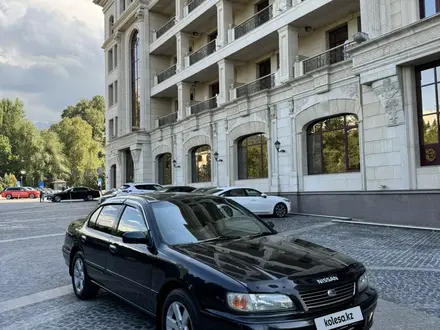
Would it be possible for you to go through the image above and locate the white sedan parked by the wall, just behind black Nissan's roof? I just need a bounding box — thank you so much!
[205,187,291,218]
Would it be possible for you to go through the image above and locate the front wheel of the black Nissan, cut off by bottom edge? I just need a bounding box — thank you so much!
[160,289,202,330]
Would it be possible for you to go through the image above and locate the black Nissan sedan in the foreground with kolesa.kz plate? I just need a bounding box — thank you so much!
[62,193,378,330]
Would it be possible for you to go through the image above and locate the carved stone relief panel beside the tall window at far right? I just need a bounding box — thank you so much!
[373,76,404,126]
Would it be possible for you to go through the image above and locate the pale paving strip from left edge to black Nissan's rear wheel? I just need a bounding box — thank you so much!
[0,285,72,314]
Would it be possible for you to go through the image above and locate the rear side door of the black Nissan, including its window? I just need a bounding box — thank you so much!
[80,204,122,287]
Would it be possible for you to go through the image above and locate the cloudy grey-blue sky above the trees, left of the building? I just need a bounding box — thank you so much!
[0,0,105,121]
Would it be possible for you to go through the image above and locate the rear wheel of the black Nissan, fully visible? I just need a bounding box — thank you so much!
[72,252,99,300]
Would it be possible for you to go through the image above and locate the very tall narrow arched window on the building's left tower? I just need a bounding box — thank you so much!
[131,30,141,131]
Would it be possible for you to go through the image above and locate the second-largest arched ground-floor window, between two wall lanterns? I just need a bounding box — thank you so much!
[238,134,269,180]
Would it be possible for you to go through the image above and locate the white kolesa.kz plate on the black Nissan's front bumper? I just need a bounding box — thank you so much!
[315,306,364,330]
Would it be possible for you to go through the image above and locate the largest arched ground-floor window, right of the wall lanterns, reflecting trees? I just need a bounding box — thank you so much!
[307,115,360,174]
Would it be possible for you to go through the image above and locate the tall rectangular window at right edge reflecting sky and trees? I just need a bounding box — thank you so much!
[416,60,440,166]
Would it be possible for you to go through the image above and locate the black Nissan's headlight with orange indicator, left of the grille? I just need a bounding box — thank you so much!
[227,293,294,312]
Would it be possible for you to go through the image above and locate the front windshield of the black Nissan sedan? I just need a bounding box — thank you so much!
[152,197,274,245]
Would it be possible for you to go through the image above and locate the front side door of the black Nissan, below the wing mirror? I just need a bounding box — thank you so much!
[107,201,155,312]
